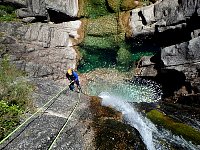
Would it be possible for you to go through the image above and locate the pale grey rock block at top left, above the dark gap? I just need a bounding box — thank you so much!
[12,0,79,18]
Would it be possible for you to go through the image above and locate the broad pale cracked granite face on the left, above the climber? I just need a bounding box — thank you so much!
[0,21,81,79]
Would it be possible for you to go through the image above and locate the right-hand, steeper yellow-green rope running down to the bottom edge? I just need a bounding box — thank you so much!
[48,93,80,150]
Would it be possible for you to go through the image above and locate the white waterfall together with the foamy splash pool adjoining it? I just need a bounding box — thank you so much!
[88,78,200,150]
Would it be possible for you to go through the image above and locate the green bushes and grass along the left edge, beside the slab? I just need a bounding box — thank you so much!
[0,57,33,140]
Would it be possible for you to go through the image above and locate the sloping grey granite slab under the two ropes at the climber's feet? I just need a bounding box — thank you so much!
[0,79,95,150]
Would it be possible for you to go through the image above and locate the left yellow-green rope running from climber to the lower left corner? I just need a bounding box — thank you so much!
[0,83,71,145]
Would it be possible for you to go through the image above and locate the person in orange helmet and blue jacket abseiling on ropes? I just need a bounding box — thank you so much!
[66,68,81,92]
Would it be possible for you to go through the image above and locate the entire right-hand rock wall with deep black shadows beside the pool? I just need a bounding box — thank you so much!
[129,0,200,96]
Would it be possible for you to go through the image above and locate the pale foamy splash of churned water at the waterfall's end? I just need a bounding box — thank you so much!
[88,78,162,102]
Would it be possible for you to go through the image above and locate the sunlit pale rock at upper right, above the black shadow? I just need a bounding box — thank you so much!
[130,0,200,37]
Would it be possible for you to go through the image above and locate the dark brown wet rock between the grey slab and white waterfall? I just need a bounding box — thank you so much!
[90,97,146,150]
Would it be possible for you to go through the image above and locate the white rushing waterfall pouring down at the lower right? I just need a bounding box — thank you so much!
[99,92,200,150]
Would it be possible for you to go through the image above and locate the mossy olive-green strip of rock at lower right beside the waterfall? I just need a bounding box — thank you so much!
[147,110,200,145]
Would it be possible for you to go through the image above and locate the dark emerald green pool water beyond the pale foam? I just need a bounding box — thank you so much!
[78,48,155,73]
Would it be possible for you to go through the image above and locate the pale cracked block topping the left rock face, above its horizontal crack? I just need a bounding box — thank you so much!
[24,21,81,47]
